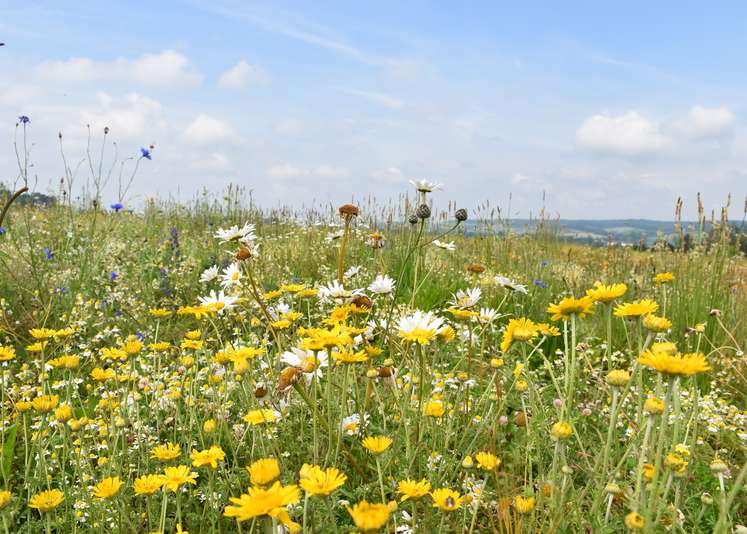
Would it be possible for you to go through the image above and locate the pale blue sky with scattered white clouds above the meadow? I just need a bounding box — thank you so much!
[0,0,747,220]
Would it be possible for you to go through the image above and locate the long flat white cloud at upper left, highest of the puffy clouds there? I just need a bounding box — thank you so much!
[36,50,202,87]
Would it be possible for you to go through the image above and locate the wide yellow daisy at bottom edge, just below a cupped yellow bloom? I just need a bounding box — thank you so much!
[223,482,301,532]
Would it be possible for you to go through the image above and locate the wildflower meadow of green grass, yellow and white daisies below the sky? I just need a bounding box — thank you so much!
[0,184,747,533]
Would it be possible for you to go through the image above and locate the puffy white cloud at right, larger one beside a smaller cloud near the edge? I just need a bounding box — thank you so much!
[576,111,672,156]
